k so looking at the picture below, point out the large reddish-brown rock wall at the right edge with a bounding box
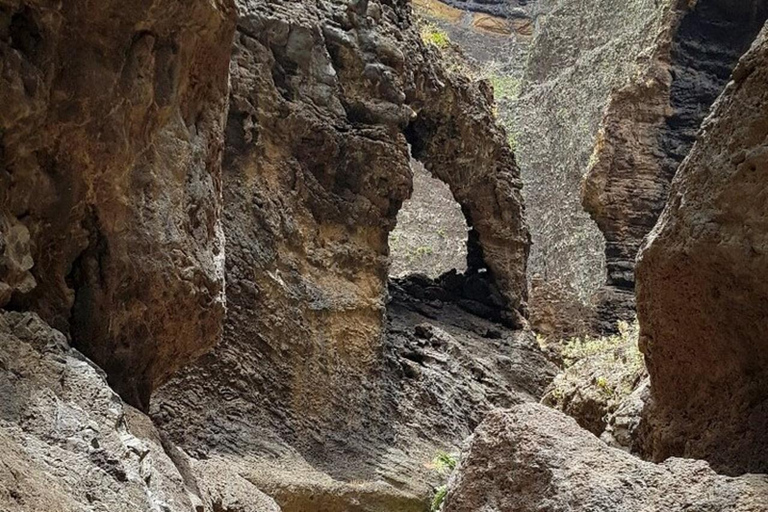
[638,22,768,473]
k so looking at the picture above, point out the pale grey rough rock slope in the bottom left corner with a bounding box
[0,313,279,512]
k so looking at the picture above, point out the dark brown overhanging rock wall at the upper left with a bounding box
[0,0,234,408]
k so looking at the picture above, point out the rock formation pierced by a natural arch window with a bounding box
[153,1,554,511]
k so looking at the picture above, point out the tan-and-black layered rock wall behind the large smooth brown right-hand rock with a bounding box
[583,0,768,328]
